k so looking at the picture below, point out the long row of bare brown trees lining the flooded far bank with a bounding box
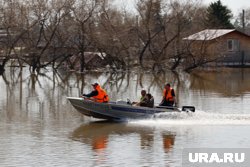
[0,0,247,73]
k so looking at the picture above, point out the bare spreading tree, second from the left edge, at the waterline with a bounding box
[24,0,76,72]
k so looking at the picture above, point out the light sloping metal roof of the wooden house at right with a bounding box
[183,29,237,41]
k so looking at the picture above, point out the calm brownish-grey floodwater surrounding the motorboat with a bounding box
[0,68,250,167]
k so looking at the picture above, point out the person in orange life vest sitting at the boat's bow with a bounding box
[83,83,109,103]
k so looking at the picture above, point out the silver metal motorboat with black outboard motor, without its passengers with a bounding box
[67,97,195,121]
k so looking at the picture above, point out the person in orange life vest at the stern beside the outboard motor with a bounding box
[160,83,177,107]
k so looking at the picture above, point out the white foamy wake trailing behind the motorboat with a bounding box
[130,111,250,125]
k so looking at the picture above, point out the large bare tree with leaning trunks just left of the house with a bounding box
[135,0,203,70]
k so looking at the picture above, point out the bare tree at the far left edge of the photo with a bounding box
[0,0,26,73]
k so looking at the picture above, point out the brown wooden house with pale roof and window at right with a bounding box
[183,29,250,67]
